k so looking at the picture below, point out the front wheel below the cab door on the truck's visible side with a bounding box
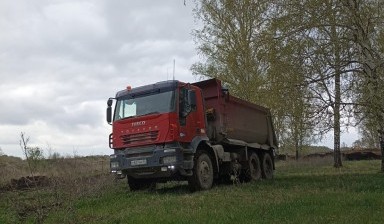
[188,151,213,191]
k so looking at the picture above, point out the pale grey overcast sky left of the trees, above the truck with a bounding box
[0,0,360,156]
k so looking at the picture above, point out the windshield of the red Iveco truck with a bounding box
[114,91,176,121]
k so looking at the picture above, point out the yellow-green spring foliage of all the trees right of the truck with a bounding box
[192,0,384,166]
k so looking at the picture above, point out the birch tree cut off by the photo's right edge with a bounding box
[343,0,384,172]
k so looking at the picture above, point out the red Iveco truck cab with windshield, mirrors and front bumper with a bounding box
[107,81,207,189]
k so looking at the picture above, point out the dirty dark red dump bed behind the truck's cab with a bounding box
[193,79,277,149]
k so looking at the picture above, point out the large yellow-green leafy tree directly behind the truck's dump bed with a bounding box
[192,0,312,156]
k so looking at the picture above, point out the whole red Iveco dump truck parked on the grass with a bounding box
[107,79,278,191]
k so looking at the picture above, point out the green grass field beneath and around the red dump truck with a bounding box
[0,159,384,223]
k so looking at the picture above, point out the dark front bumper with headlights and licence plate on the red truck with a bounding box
[110,145,193,178]
